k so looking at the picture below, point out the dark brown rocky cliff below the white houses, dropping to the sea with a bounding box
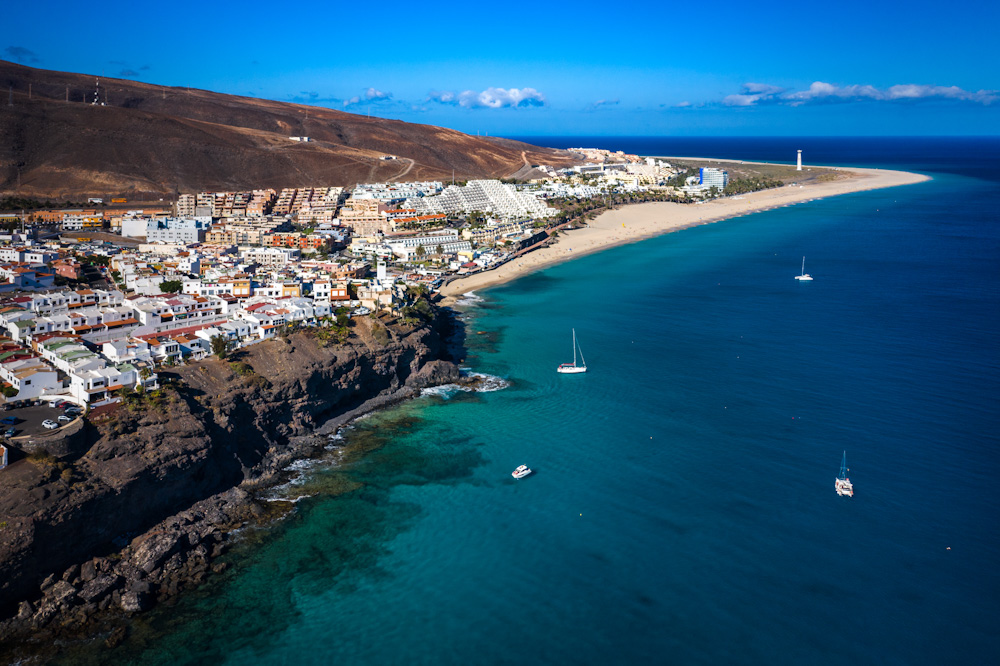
[0,309,462,663]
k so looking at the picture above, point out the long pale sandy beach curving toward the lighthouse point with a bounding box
[441,160,929,304]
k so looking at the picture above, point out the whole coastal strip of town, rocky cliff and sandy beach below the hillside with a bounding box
[0,131,924,650]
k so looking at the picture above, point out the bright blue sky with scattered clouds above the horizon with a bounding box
[0,0,1000,136]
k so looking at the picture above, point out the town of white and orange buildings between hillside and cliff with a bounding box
[0,148,744,465]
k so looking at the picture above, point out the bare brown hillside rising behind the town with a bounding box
[0,61,576,199]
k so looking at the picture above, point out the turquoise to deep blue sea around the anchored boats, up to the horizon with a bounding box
[88,137,1000,666]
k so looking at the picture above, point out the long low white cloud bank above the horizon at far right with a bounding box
[722,81,1000,106]
